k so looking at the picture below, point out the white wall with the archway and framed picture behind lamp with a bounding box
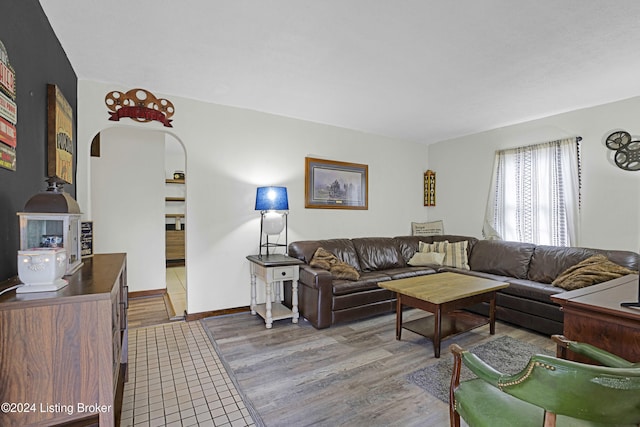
[77,81,427,313]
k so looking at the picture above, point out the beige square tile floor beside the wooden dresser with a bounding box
[121,321,255,427]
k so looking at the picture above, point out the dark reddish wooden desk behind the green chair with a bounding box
[551,274,640,362]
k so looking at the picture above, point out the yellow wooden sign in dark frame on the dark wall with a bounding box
[47,84,73,184]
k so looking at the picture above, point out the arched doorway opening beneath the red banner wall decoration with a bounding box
[90,126,188,319]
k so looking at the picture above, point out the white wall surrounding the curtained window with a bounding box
[428,97,640,252]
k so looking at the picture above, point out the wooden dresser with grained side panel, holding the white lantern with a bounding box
[0,253,128,427]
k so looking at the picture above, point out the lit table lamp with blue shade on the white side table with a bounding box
[255,187,289,257]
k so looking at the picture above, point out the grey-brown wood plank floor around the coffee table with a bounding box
[203,310,555,427]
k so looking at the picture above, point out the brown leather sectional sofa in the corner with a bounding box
[285,235,640,335]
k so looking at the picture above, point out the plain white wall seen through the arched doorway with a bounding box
[90,128,166,291]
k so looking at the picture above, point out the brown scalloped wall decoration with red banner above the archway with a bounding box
[104,89,175,128]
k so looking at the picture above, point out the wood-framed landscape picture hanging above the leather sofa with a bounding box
[304,157,369,210]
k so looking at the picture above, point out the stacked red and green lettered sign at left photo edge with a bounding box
[0,41,18,171]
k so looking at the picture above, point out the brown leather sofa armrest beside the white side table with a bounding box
[298,264,333,329]
